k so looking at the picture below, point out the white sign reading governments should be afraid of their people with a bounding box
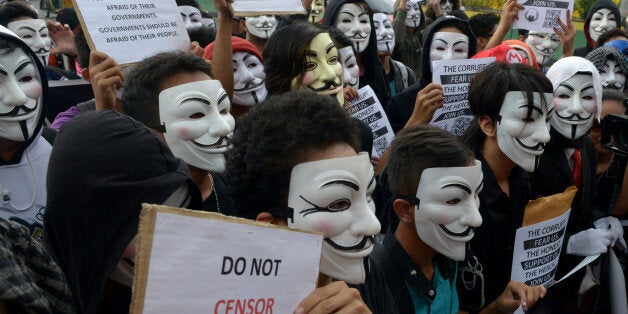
[73,0,190,65]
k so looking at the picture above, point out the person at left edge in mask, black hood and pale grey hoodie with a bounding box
[0,26,54,241]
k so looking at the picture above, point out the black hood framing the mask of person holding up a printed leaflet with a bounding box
[419,15,477,88]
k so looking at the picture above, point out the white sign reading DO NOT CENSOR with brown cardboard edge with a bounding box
[131,204,323,313]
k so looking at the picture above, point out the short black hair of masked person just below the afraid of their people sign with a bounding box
[121,51,212,132]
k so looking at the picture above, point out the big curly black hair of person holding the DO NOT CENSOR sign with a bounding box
[225,91,360,219]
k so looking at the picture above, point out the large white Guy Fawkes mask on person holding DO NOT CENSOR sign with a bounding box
[288,152,380,284]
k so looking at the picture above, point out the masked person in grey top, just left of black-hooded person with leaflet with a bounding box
[373,13,416,96]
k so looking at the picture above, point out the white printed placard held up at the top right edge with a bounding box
[512,0,574,34]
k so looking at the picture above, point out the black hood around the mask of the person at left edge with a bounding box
[0,25,48,146]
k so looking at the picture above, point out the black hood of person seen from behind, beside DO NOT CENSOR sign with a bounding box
[44,110,200,313]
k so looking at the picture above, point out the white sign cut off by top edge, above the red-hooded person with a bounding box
[230,0,307,16]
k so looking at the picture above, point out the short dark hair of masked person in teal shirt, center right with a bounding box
[386,124,475,196]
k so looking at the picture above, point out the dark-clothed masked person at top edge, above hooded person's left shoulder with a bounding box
[392,0,425,77]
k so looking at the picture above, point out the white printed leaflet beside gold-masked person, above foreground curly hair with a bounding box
[346,85,395,158]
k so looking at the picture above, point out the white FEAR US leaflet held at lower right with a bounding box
[510,209,571,288]
